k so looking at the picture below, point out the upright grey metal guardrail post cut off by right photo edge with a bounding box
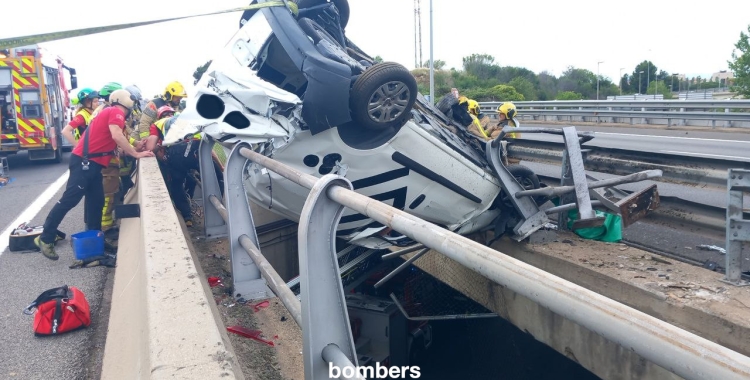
[724,169,750,286]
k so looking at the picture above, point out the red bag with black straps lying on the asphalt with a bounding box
[23,285,91,336]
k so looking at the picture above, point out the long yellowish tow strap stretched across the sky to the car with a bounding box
[0,0,298,49]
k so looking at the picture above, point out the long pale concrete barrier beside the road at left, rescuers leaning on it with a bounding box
[102,158,244,379]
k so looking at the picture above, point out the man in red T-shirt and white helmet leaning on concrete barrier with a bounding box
[34,90,154,260]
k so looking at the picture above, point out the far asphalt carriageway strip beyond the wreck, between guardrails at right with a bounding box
[521,124,750,162]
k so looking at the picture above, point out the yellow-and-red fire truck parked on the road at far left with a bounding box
[0,45,77,162]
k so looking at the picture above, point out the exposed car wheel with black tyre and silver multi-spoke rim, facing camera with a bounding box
[350,62,417,130]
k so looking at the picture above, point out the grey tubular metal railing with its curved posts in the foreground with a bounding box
[200,138,750,380]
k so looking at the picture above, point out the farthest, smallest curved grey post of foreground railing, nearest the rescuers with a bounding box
[198,134,227,239]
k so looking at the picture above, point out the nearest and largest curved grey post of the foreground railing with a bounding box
[298,174,357,380]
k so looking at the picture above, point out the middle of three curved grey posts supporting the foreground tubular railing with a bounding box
[224,143,271,300]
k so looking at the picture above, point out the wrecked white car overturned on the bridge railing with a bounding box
[165,0,660,248]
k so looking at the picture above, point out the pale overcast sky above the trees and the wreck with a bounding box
[0,0,750,96]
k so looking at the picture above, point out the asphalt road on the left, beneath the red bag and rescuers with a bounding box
[0,154,114,380]
